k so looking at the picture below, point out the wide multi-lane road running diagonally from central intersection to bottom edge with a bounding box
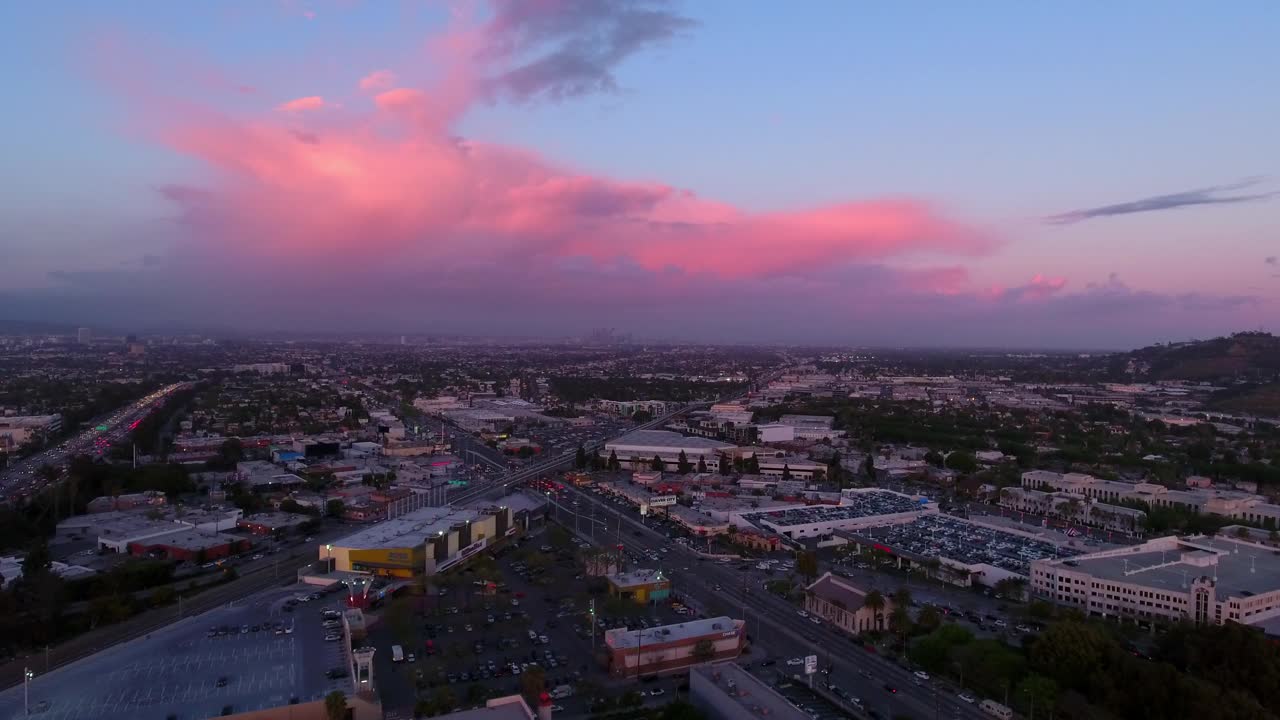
[552,486,986,720]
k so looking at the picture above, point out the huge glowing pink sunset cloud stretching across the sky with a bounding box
[115,3,1000,308]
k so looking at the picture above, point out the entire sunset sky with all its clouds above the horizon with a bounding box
[0,0,1280,348]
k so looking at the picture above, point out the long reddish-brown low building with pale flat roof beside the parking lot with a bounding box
[604,618,745,678]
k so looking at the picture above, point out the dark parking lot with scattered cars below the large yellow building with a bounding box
[369,525,682,714]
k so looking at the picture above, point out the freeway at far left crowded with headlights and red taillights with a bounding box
[0,383,191,501]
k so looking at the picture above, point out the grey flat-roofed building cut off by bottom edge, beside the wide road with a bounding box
[689,662,809,720]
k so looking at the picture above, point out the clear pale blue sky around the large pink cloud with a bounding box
[0,1,1280,345]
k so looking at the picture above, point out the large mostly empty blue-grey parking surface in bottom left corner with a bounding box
[0,587,349,720]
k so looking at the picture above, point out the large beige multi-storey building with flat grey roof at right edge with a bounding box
[1030,536,1280,625]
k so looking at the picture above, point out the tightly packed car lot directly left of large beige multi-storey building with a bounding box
[859,514,1079,577]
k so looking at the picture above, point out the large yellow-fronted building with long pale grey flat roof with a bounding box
[319,505,516,578]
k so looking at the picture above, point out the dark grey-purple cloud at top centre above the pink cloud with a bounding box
[483,0,695,101]
